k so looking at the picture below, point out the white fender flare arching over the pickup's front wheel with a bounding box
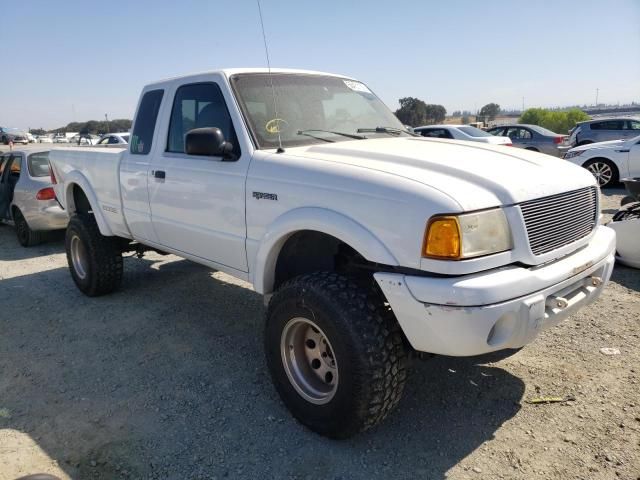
[252,207,398,294]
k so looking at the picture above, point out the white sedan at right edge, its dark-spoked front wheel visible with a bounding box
[564,136,640,187]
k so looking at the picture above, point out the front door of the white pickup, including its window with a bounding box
[148,77,250,272]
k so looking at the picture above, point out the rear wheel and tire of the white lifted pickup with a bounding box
[65,213,122,297]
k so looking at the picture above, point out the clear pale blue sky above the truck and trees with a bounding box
[0,0,640,128]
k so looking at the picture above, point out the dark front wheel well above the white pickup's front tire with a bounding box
[273,230,374,290]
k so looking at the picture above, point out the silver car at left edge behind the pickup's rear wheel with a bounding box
[0,150,68,247]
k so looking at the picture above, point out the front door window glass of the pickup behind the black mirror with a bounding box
[167,83,240,158]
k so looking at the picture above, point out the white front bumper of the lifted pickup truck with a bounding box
[374,226,615,356]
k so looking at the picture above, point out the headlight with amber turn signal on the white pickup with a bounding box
[422,208,513,260]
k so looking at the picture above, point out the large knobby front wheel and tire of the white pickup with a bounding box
[265,272,408,438]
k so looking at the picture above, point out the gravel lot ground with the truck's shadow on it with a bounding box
[0,178,640,480]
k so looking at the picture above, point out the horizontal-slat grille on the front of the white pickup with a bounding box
[520,187,598,255]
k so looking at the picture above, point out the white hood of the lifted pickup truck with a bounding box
[285,137,595,211]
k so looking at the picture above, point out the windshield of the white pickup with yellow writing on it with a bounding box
[231,73,411,148]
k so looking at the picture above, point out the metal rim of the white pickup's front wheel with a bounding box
[280,317,339,405]
